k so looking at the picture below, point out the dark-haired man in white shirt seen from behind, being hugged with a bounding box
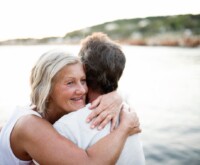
[54,33,145,165]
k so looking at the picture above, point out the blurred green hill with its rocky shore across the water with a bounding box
[0,14,200,47]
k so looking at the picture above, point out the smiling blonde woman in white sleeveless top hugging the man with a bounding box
[0,51,140,165]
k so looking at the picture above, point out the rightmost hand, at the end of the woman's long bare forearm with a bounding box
[119,107,141,136]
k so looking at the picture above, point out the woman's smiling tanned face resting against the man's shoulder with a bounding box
[48,63,88,114]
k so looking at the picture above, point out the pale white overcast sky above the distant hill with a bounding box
[0,0,200,41]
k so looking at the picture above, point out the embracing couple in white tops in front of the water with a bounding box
[0,33,145,165]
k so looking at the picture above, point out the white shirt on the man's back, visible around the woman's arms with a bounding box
[54,105,145,165]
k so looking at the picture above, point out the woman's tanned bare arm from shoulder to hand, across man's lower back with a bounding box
[11,112,140,165]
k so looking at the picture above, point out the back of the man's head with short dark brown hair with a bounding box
[79,33,126,94]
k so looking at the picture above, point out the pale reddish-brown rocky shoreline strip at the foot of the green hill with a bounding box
[0,36,200,47]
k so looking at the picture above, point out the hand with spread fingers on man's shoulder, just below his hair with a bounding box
[87,91,122,131]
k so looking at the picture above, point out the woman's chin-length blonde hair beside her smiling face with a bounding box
[30,50,81,113]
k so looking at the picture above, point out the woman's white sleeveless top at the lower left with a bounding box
[0,106,41,165]
